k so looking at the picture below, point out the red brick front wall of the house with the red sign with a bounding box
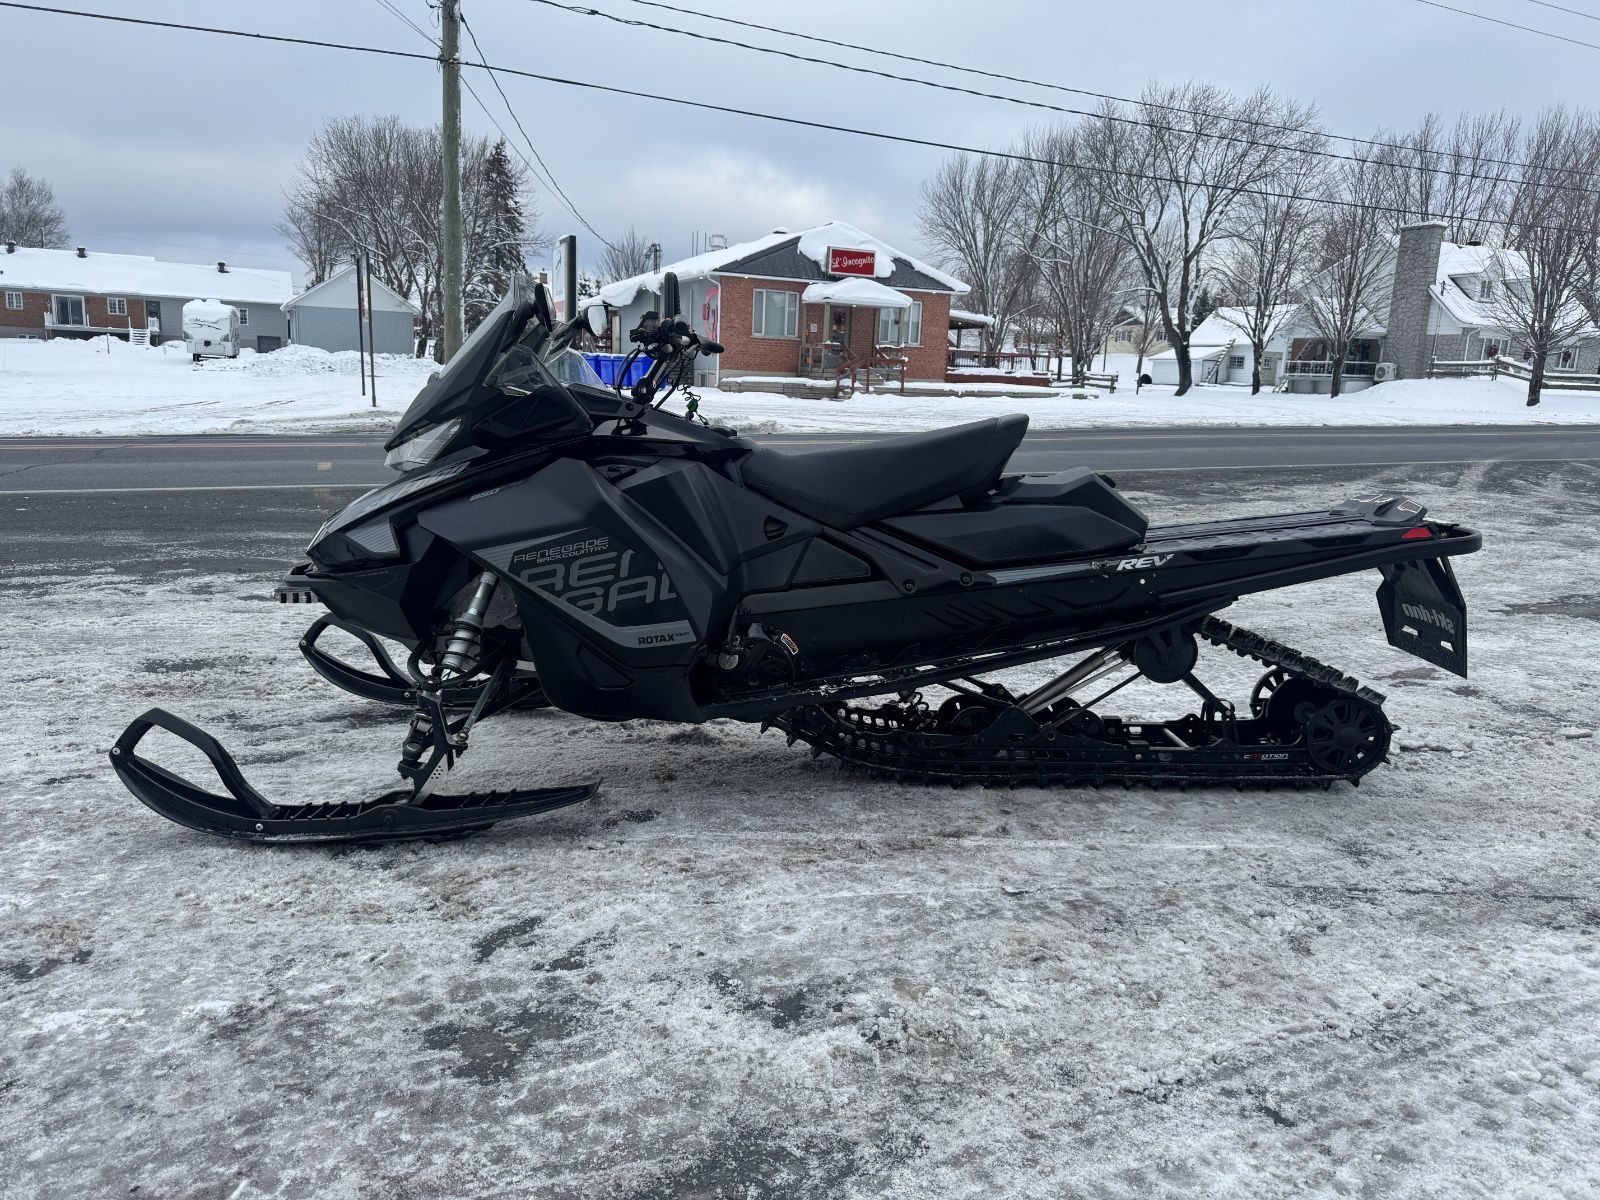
[718,275,950,379]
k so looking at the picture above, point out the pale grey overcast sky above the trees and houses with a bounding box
[0,0,1600,281]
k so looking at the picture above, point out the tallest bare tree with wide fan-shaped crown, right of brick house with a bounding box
[1083,83,1322,395]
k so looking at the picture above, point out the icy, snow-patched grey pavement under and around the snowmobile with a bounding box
[0,464,1600,1200]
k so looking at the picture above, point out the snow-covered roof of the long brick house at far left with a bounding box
[0,246,294,304]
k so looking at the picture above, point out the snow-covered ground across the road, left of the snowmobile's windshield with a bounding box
[0,338,435,437]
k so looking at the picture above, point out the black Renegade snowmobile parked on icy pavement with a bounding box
[110,275,1482,842]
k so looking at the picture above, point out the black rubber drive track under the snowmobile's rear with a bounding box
[773,616,1392,787]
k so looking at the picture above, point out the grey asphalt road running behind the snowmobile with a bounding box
[0,426,1600,496]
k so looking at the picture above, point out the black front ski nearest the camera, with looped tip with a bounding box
[110,709,598,845]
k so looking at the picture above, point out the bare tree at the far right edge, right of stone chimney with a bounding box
[1478,109,1600,406]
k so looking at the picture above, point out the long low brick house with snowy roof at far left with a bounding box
[0,242,294,350]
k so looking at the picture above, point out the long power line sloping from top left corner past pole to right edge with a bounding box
[0,0,1584,234]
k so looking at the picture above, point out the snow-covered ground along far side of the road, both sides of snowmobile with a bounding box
[0,339,1600,437]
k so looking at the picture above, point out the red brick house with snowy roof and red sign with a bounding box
[598,221,968,384]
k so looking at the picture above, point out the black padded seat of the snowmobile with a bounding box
[742,414,1027,530]
